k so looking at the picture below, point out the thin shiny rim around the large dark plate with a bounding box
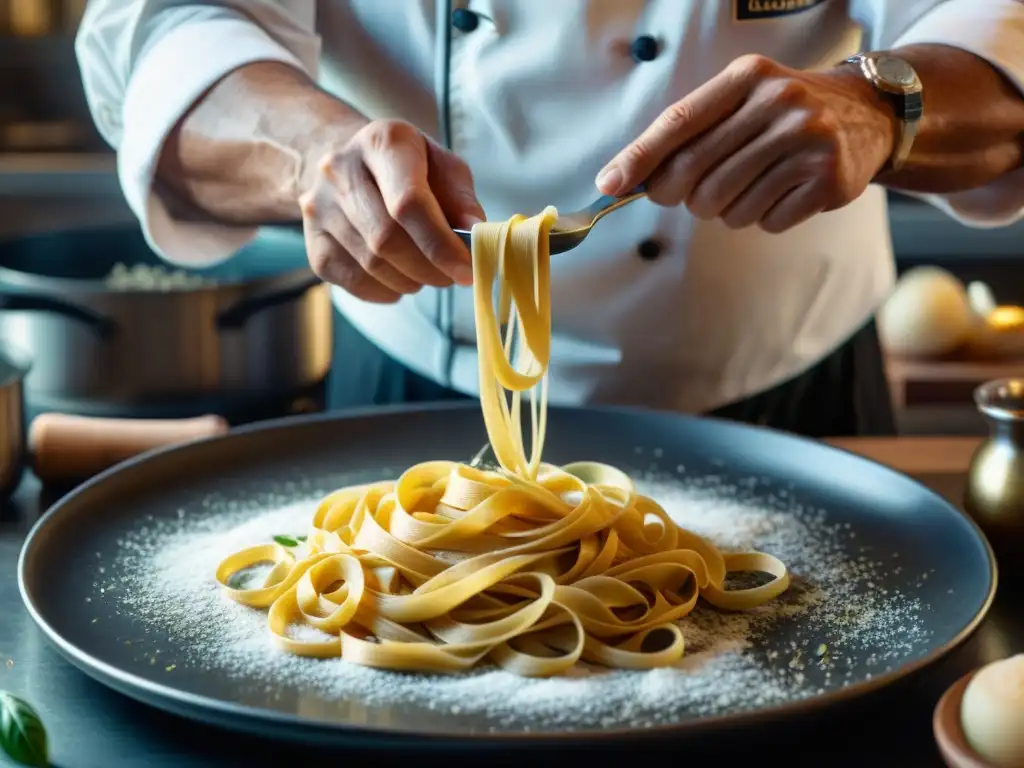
[17,399,998,746]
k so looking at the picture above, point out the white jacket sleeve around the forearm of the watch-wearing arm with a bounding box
[854,0,1024,228]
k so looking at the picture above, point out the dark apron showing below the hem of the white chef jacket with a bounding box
[328,315,896,437]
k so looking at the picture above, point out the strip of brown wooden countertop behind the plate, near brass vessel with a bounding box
[825,437,983,474]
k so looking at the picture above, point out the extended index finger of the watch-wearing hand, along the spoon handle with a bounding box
[596,55,778,195]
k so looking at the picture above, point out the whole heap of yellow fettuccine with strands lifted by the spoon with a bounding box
[216,208,790,677]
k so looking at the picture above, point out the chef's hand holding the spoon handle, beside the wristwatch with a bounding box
[597,55,895,232]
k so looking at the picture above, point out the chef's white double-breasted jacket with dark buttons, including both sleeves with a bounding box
[77,0,1024,412]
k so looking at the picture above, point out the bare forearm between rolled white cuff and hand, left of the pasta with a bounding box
[157,61,367,224]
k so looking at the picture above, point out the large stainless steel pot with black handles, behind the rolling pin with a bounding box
[0,227,332,404]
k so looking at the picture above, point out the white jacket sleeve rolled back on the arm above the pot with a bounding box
[75,0,319,266]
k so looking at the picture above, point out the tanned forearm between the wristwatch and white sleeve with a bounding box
[878,45,1024,194]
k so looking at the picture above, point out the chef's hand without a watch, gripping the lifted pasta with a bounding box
[299,120,483,303]
